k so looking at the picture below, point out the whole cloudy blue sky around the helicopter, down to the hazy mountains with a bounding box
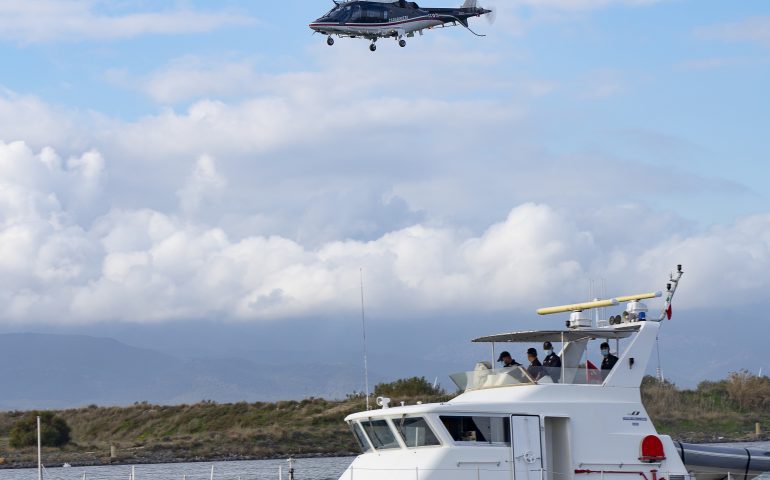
[0,0,770,326]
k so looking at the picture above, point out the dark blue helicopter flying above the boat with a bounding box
[309,0,494,52]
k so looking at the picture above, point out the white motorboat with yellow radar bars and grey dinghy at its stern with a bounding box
[340,266,770,480]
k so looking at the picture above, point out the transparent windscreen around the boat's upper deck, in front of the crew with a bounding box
[449,365,609,392]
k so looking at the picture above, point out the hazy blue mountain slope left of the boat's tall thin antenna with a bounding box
[0,334,372,410]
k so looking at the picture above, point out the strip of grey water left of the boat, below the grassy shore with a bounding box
[0,457,353,480]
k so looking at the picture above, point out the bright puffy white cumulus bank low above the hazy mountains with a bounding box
[0,142,770,322]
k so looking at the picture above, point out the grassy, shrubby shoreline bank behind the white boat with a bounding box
[0,371,770,469]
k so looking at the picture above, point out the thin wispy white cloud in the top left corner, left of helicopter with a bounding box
[0,0,254,43]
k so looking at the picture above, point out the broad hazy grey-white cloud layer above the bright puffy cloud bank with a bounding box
[0,54,745,247]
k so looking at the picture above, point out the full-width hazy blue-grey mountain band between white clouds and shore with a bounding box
[0,307,770,410]
